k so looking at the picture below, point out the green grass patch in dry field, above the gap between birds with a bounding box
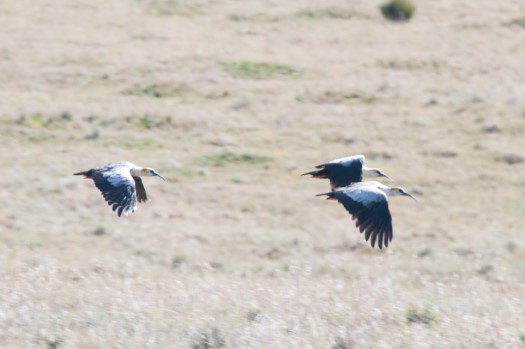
[221,61,298,79]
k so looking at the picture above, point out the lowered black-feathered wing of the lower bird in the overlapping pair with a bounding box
[334,190,393,249]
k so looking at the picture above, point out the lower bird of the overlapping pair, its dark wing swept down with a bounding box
[317,181,416,249]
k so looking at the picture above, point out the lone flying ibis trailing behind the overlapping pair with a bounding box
[74,161,166,217]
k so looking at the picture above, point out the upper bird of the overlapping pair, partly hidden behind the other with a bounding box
[302,155,392,188]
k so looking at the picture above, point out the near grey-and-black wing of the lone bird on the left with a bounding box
[93,167,137,217]
